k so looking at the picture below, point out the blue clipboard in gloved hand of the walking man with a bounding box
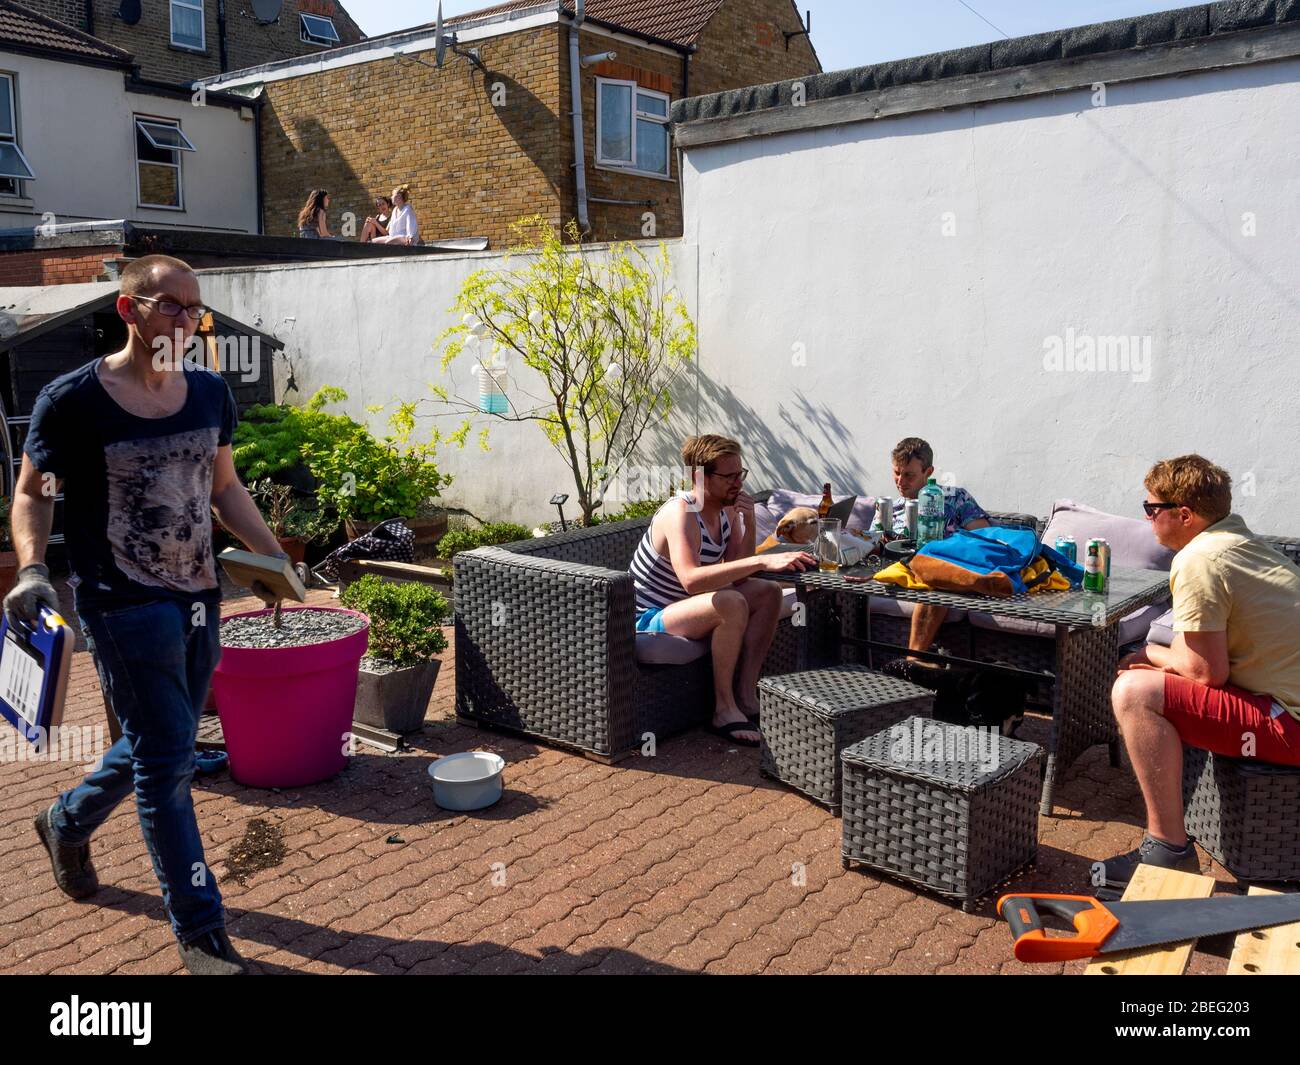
[0,606,77,745]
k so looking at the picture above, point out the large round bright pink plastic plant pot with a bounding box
[212,607,371,788]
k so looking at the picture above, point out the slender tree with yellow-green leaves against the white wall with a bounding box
[430,216,697,524]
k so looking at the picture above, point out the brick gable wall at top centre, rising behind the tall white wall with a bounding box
[690,0,822,96]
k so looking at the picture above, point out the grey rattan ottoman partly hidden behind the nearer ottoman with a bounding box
[758,664,935,813]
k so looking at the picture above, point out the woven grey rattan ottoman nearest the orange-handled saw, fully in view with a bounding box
[841,718,1043,909]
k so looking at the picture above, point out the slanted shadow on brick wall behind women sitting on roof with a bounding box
[261,100,366,239]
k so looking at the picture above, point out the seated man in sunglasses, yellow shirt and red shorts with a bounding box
[1102,455,1300,888]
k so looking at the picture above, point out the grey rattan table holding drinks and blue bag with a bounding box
[759,566,1169,815]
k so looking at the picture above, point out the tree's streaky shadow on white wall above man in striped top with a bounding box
[641,365,873,494]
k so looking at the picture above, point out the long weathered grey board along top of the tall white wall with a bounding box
[672,22,1300,148]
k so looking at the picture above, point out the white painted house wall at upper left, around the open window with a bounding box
[0,52,257,233]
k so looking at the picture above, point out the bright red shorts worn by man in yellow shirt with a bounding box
[1165,674,1300,766]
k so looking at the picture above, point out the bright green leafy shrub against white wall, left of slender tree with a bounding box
[303,403,451,545]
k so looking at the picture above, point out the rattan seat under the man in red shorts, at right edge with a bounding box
[1183,746,1300,880]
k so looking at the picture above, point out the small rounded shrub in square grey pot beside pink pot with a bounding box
[339,573,451,732]
